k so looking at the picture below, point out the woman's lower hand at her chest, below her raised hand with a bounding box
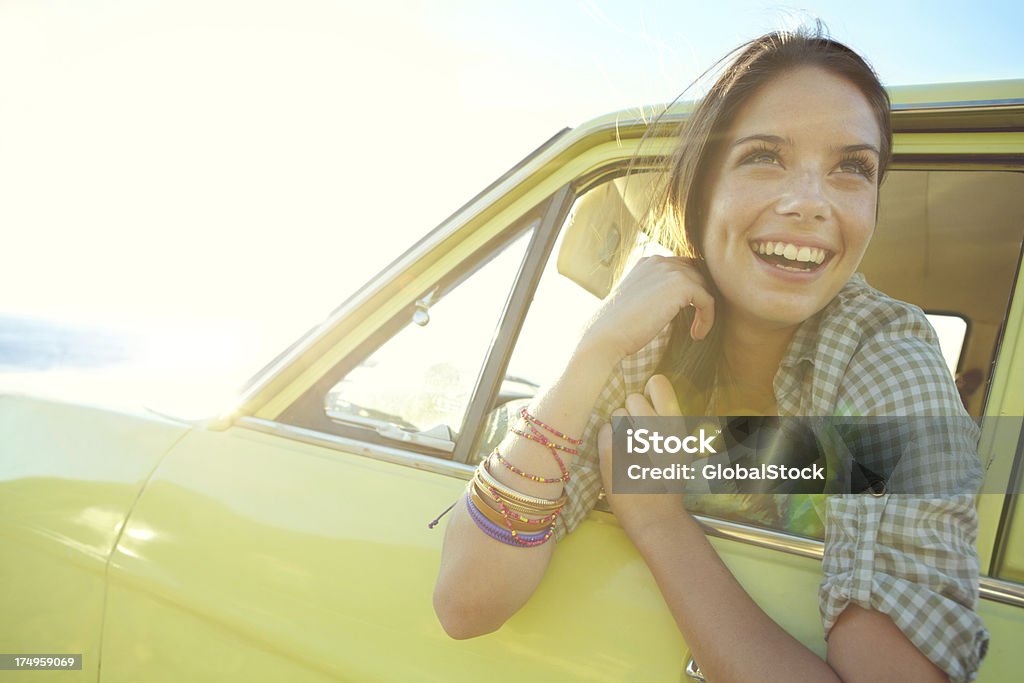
[597,375,687,543]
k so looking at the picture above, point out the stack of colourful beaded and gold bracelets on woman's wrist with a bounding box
[466,408,581,548]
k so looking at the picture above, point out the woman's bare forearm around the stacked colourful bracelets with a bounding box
[433,345,617,638]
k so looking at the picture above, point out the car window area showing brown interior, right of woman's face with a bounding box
[861,168,1024,417]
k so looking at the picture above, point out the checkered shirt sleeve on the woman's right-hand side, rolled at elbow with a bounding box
[819,300,988,683]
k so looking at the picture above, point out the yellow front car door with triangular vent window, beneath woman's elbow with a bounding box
[96,183,696,681]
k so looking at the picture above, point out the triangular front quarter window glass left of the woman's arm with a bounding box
[324,226,532,451]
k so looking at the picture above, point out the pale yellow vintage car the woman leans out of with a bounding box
[0,80,1024,683]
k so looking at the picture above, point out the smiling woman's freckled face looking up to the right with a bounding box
[702,67,882,328]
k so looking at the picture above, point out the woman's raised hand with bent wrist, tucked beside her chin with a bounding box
[581,256,715,361]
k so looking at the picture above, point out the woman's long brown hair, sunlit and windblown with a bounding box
[629,22,892,412]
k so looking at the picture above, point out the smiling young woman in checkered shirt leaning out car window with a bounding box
[434,26,987,683]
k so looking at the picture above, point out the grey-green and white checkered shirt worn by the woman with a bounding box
[556,274,988,682]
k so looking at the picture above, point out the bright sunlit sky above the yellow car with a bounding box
[0,0,1024,413]
